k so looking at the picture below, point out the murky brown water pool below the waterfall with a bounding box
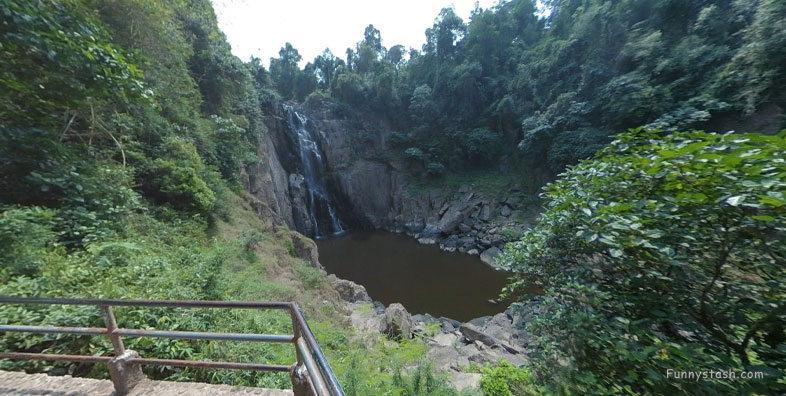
[317,231,511,321]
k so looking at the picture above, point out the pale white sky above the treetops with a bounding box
[212,0,498,66]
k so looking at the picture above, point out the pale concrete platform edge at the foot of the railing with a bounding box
[0,371,292,396]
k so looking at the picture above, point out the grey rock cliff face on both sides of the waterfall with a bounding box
[251,100,531,264]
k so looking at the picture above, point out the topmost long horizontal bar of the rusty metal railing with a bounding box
[0,296,291,310]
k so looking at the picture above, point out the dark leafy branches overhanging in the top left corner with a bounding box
[0,0,151,126]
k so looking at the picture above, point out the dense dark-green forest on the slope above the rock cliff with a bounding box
[268,0,786,175]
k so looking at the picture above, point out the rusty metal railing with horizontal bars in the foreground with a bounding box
[0,296,344,396]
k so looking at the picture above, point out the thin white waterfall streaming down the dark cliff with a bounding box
[284,105,344,237]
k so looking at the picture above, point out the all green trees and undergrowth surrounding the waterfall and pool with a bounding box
[0,0,786,396]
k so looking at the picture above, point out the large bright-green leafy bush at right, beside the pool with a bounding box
[503,130,786,394]
